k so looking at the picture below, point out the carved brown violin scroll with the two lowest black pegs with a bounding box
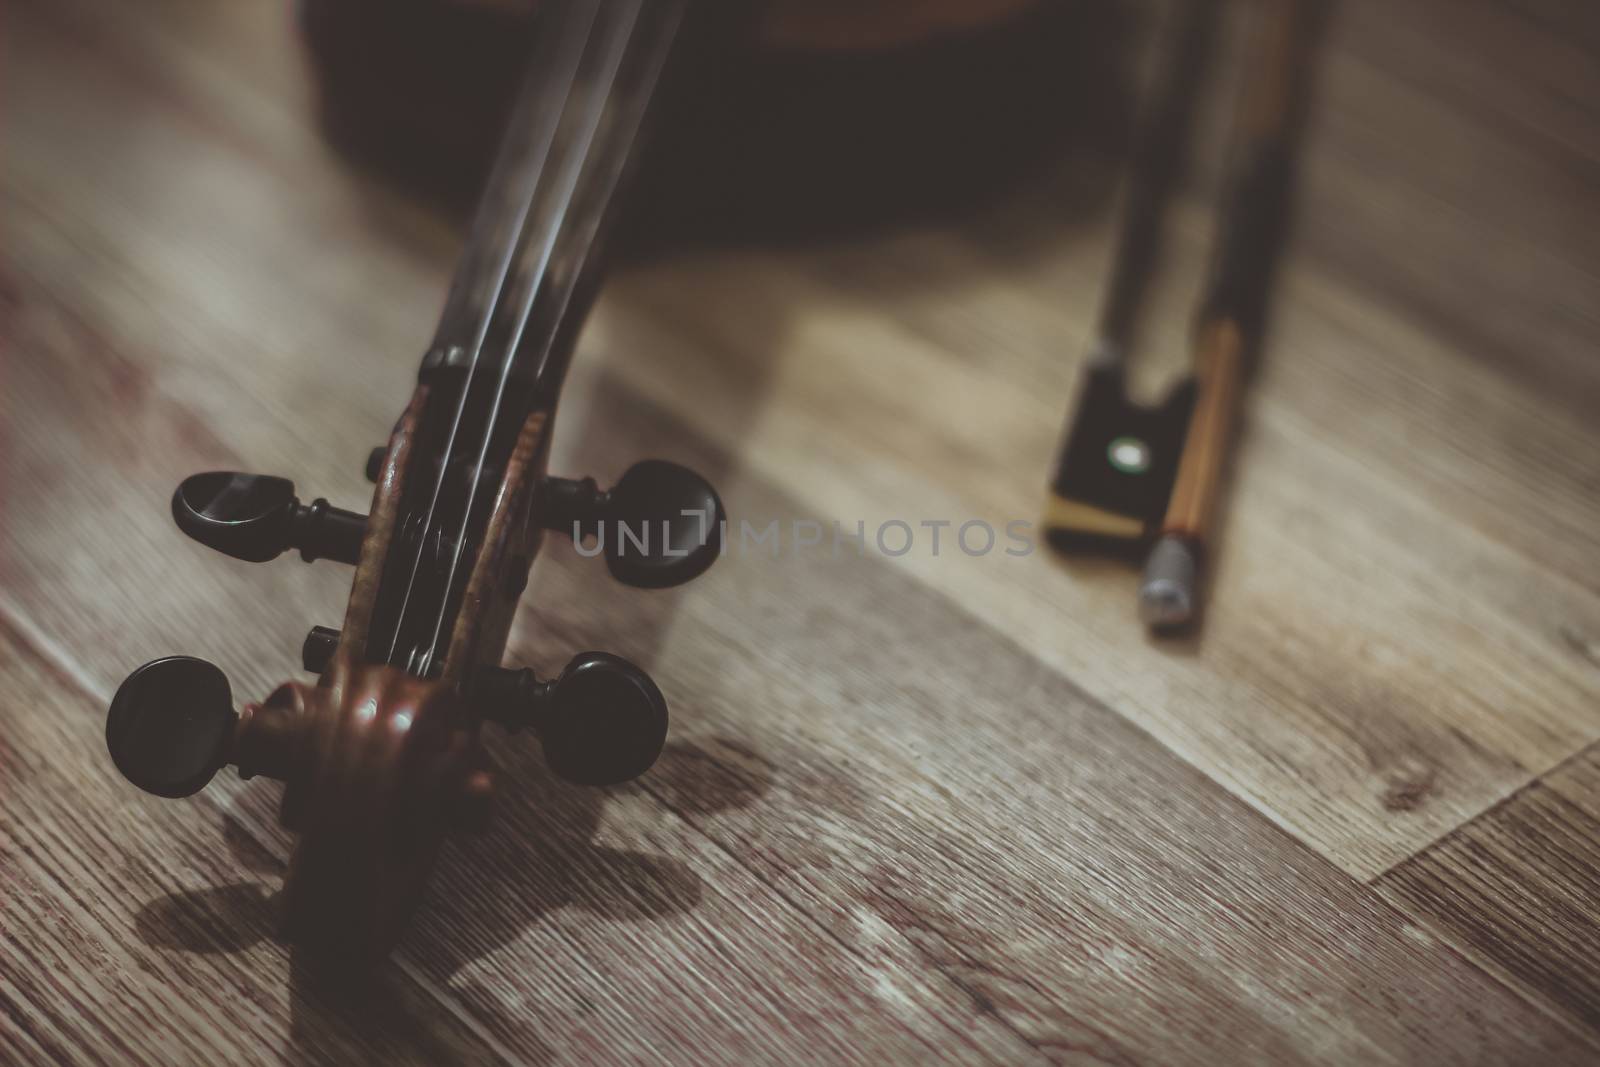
[106,639,667,963]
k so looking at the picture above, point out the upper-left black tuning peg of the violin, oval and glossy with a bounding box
[173,470,366,563]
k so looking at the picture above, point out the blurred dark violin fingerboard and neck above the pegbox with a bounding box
[422,0,685,398]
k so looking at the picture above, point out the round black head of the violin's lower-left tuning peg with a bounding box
[106,656,238,798]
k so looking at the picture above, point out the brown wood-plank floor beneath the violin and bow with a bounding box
[0,0,1600,1065]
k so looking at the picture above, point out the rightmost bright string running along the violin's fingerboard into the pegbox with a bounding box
[424,0,656,670]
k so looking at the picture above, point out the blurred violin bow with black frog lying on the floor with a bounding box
[1045,0,1328,630]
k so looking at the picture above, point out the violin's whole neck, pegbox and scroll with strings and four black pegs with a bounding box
[106,0,1043,961]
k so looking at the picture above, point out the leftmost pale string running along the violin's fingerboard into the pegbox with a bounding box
[384,0,600,662]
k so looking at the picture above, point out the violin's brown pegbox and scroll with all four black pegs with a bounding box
[106,419,725,961]
